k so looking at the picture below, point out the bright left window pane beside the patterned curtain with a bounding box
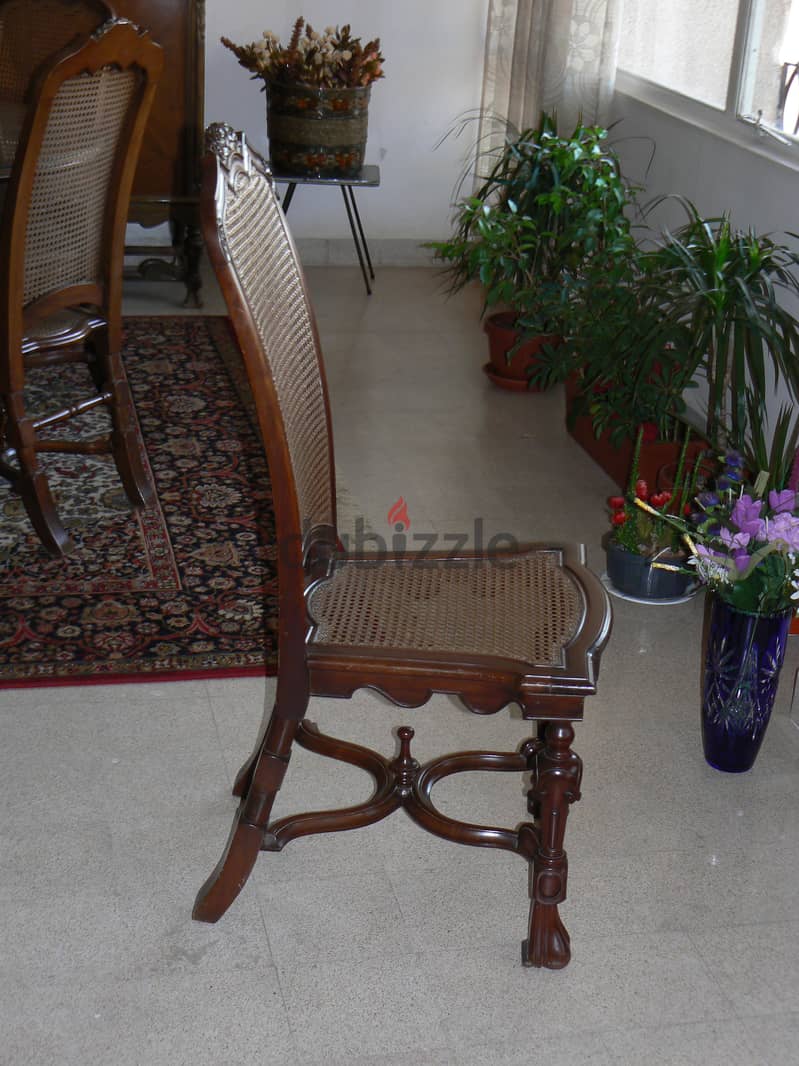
[619,0,737,109]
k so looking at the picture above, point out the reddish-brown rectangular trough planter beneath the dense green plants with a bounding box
[566,378,708,490]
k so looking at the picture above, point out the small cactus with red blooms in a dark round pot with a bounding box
[605,430,701,601]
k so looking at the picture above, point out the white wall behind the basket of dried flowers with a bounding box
[206,0,488,262]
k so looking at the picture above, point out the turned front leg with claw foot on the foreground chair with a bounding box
[522,722,583,970]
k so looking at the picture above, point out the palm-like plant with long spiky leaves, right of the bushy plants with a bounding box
[642,200,799,451]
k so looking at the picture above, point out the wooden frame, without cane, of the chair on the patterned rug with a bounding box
[0,19,163,555]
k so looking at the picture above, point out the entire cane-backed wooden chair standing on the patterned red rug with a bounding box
[0,19,163,555]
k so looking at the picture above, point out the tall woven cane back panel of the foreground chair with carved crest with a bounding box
[209,126,336,539]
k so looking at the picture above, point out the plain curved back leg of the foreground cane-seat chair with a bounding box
[192,699,307,922]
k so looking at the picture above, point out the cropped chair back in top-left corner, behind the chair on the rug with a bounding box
[0,0,114,103]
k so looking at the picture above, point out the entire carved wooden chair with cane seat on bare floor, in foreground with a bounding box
[194,124,610,968]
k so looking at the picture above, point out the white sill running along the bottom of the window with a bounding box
[616,70,799,172]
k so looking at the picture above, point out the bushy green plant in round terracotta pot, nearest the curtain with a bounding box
[427,114,633,388]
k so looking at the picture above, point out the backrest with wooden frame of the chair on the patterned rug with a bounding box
[1,20,163,328]
